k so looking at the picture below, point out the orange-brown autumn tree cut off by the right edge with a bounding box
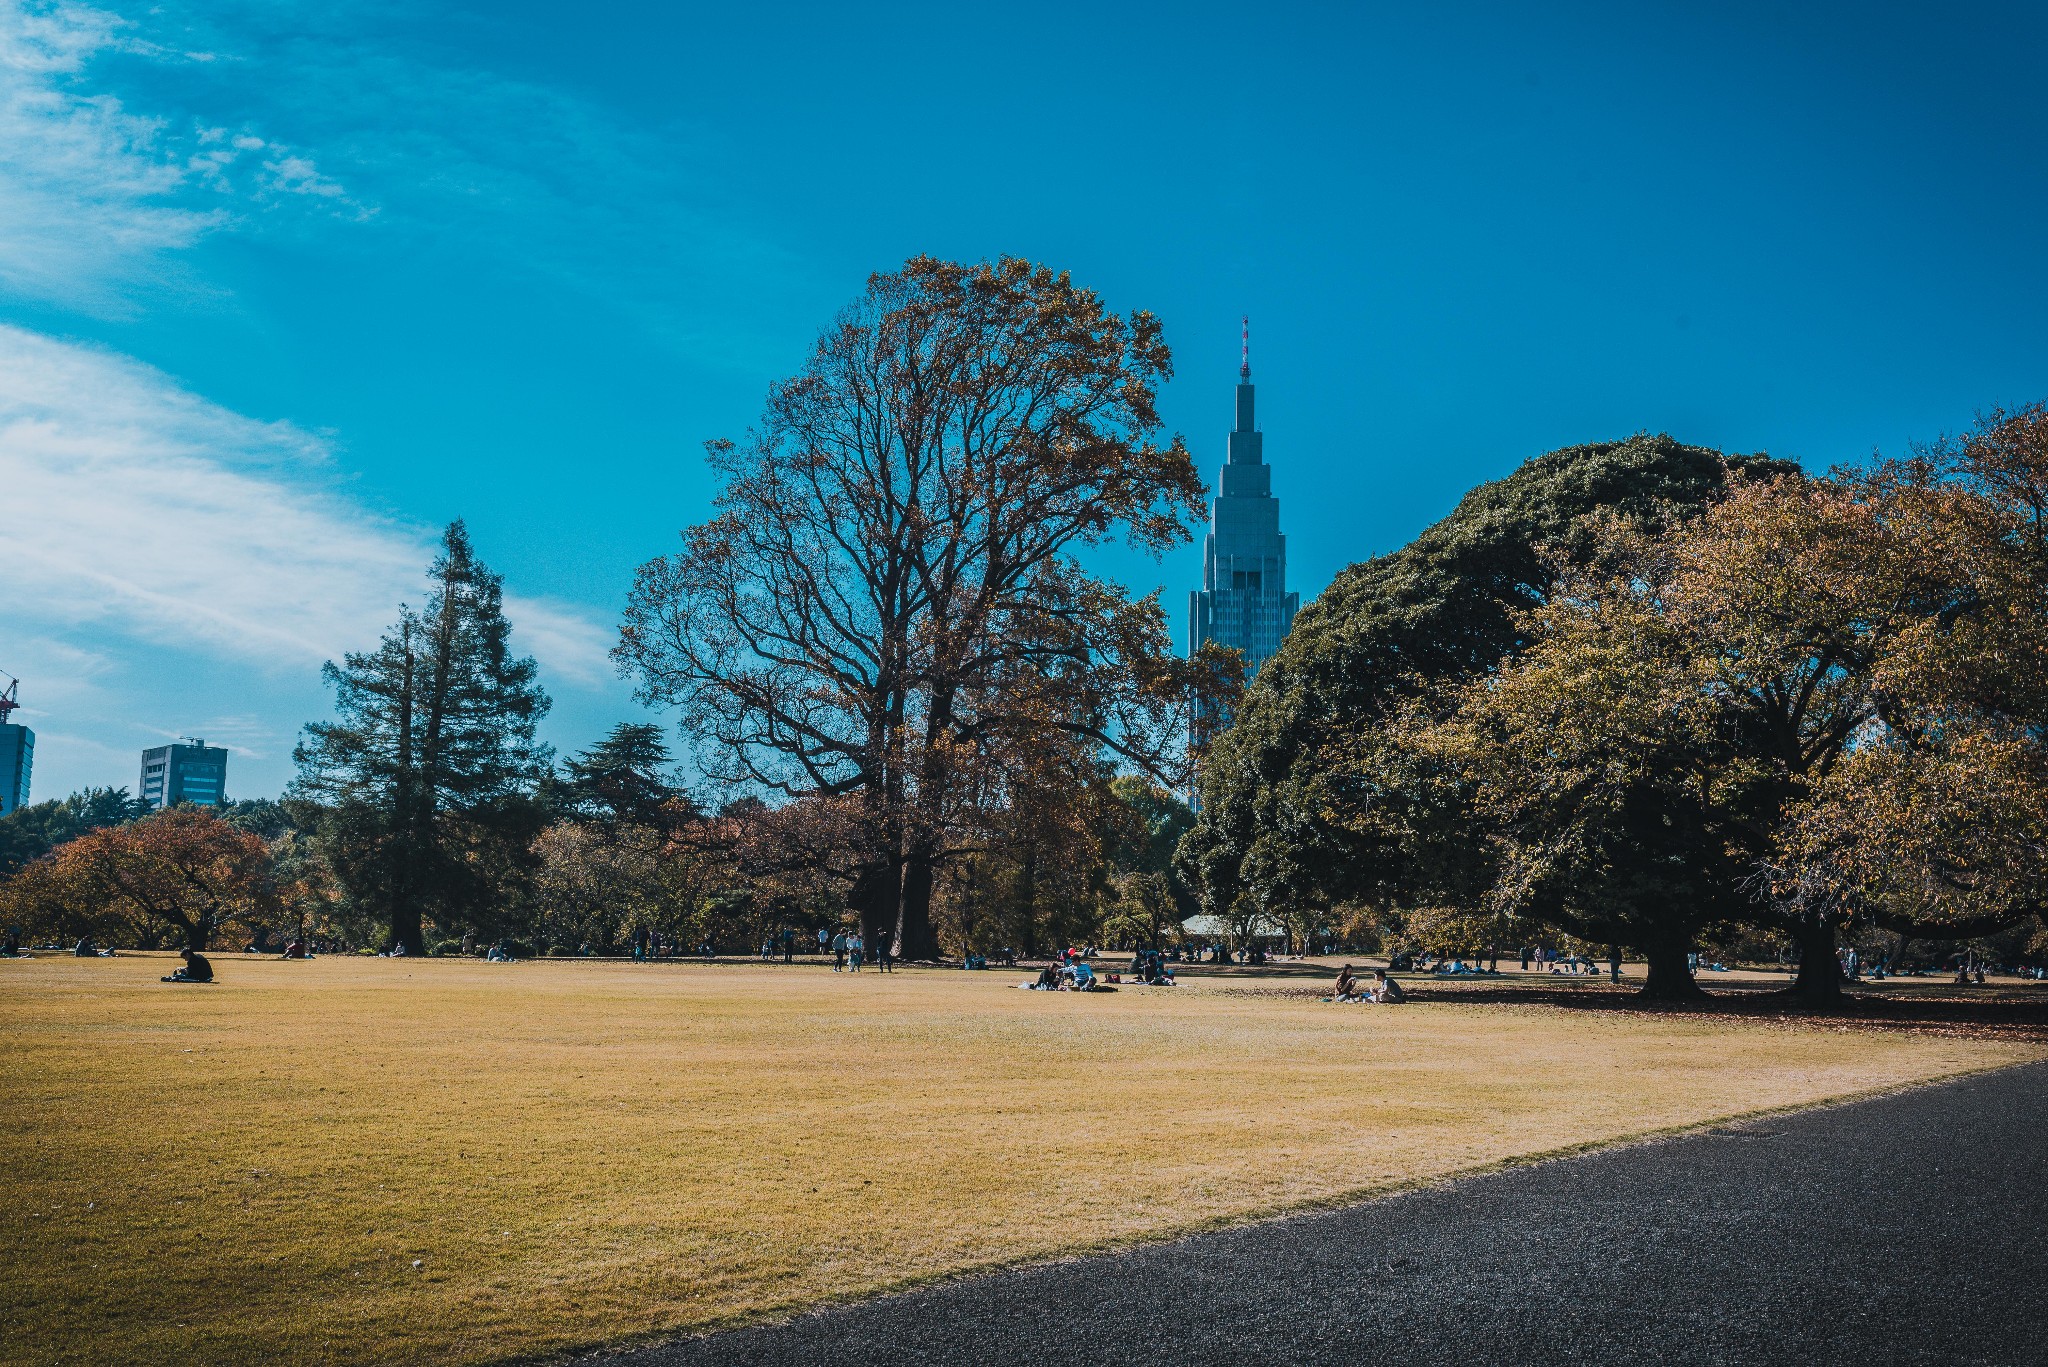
[1769,404,2048,971]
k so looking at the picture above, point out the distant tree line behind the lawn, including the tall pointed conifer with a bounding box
[0,493,1192,955]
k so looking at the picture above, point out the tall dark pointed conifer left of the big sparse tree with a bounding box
[293,523,553,953]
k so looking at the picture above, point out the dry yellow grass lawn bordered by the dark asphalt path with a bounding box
[0,955,2030,1363]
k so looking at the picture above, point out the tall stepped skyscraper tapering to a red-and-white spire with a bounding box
[1188,320,1300,696]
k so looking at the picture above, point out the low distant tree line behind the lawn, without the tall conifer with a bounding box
[0,741,1194,957]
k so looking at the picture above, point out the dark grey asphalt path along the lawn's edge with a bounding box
[606,1064,2048,1367]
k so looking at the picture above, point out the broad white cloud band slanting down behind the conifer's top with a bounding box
[0,326,610,682]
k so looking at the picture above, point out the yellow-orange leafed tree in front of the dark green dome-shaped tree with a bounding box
[1409,485,1917,996]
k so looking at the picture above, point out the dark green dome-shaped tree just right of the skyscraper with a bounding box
[1178,437,1788,967]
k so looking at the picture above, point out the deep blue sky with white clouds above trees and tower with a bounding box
[0,0,2048,797]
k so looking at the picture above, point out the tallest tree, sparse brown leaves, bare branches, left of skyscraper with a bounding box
[614,256,1214,957]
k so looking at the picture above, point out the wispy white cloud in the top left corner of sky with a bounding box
[0,0,369,314]
